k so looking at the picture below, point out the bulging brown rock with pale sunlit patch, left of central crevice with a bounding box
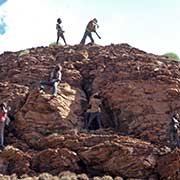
[15,84,82,148]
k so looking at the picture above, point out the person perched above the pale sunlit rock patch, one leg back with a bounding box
[39,65,62,97]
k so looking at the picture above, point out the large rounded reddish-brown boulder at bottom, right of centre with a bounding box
[78,135,157,178]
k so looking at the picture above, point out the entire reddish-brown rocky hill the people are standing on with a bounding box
[0,44,180,180]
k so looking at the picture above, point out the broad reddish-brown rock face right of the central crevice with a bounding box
[89,46,180,144]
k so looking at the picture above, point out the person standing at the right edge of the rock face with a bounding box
[170,113,180,148]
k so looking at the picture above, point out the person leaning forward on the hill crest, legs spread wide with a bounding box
[80,18,101,45]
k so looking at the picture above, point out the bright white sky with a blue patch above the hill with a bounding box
[0,0,180,56]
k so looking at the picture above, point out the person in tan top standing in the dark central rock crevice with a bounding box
[86,93,102,129]
